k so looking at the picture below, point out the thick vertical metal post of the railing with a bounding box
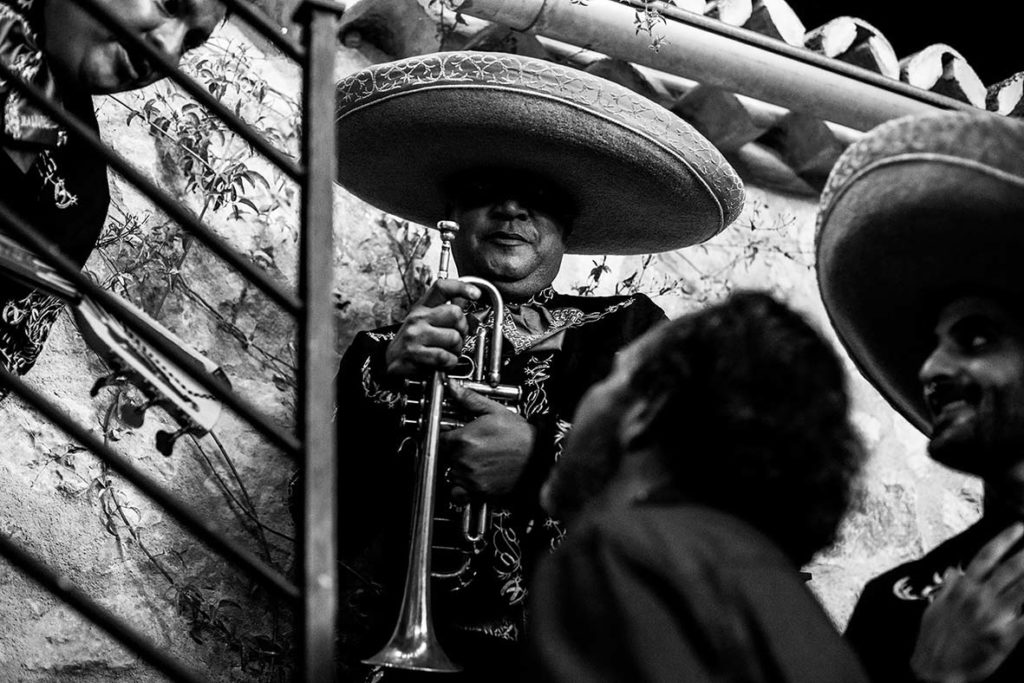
[298,0,343,683]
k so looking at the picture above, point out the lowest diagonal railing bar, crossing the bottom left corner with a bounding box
[0,533,207,683]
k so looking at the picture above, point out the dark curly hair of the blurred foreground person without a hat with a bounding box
[630,291,864,565]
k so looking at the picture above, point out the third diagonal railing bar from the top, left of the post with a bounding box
[0,60,302,315]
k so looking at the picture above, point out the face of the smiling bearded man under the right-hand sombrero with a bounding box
[920,297,1024,477]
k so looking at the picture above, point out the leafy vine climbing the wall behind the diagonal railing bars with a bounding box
[78,31,299,681]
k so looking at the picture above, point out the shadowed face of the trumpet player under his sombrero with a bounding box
[452,174,567,299]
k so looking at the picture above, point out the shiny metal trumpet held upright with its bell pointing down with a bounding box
[365,220,522,672]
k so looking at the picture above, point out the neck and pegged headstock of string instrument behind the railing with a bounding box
[0,234,230,456]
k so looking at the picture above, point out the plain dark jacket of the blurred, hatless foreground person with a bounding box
[522,500,867,683]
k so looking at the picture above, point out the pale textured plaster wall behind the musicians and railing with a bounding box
[0,6,980,681]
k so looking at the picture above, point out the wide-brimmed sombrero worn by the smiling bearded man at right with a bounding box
[816,112,1024,433]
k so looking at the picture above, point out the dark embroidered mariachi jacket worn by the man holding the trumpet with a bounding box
[338,289,666,679]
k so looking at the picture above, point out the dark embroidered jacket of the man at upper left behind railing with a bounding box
[0,0,110,385]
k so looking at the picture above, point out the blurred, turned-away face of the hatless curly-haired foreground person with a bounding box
[541,337,646,519]
